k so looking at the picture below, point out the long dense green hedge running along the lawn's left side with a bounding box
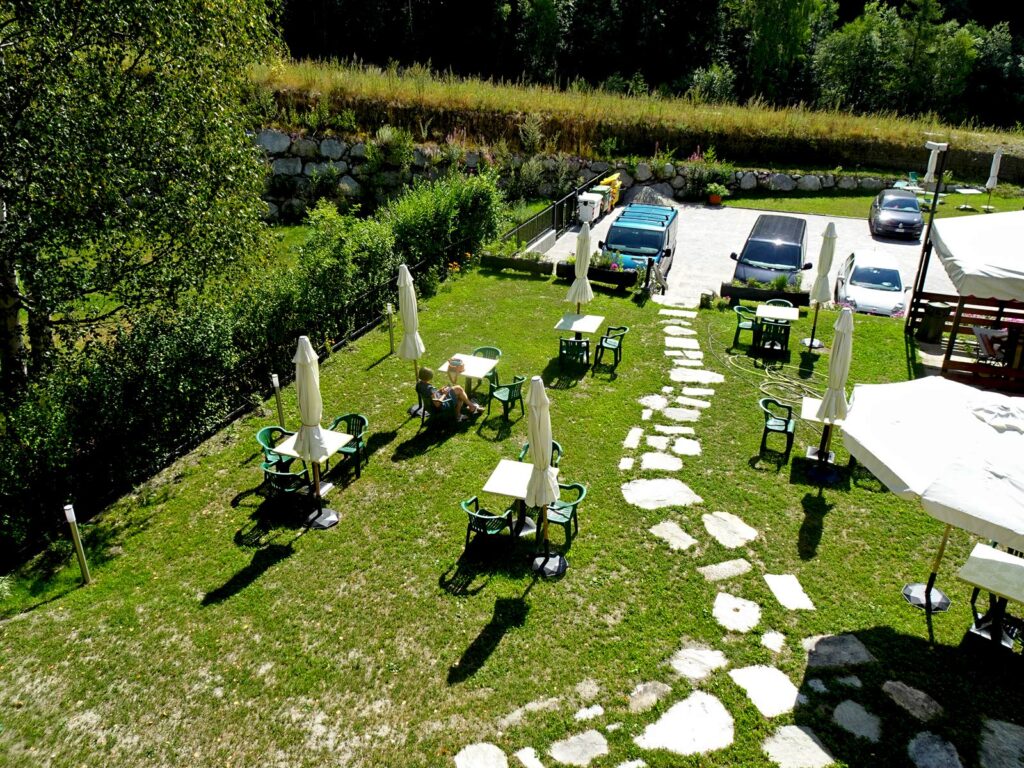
[0,174,502,564]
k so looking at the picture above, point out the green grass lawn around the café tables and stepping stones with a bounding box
[0,273,1020,768]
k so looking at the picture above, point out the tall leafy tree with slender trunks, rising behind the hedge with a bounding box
[0,0,272,393]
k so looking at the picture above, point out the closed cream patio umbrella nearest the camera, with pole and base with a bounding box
[526,376,568,575]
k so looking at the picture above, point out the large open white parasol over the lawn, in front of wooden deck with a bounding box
[843,376,1024,610]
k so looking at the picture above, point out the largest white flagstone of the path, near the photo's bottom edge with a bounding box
[633,691,734,755]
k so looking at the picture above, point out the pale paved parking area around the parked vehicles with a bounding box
[547,203,956,313]
